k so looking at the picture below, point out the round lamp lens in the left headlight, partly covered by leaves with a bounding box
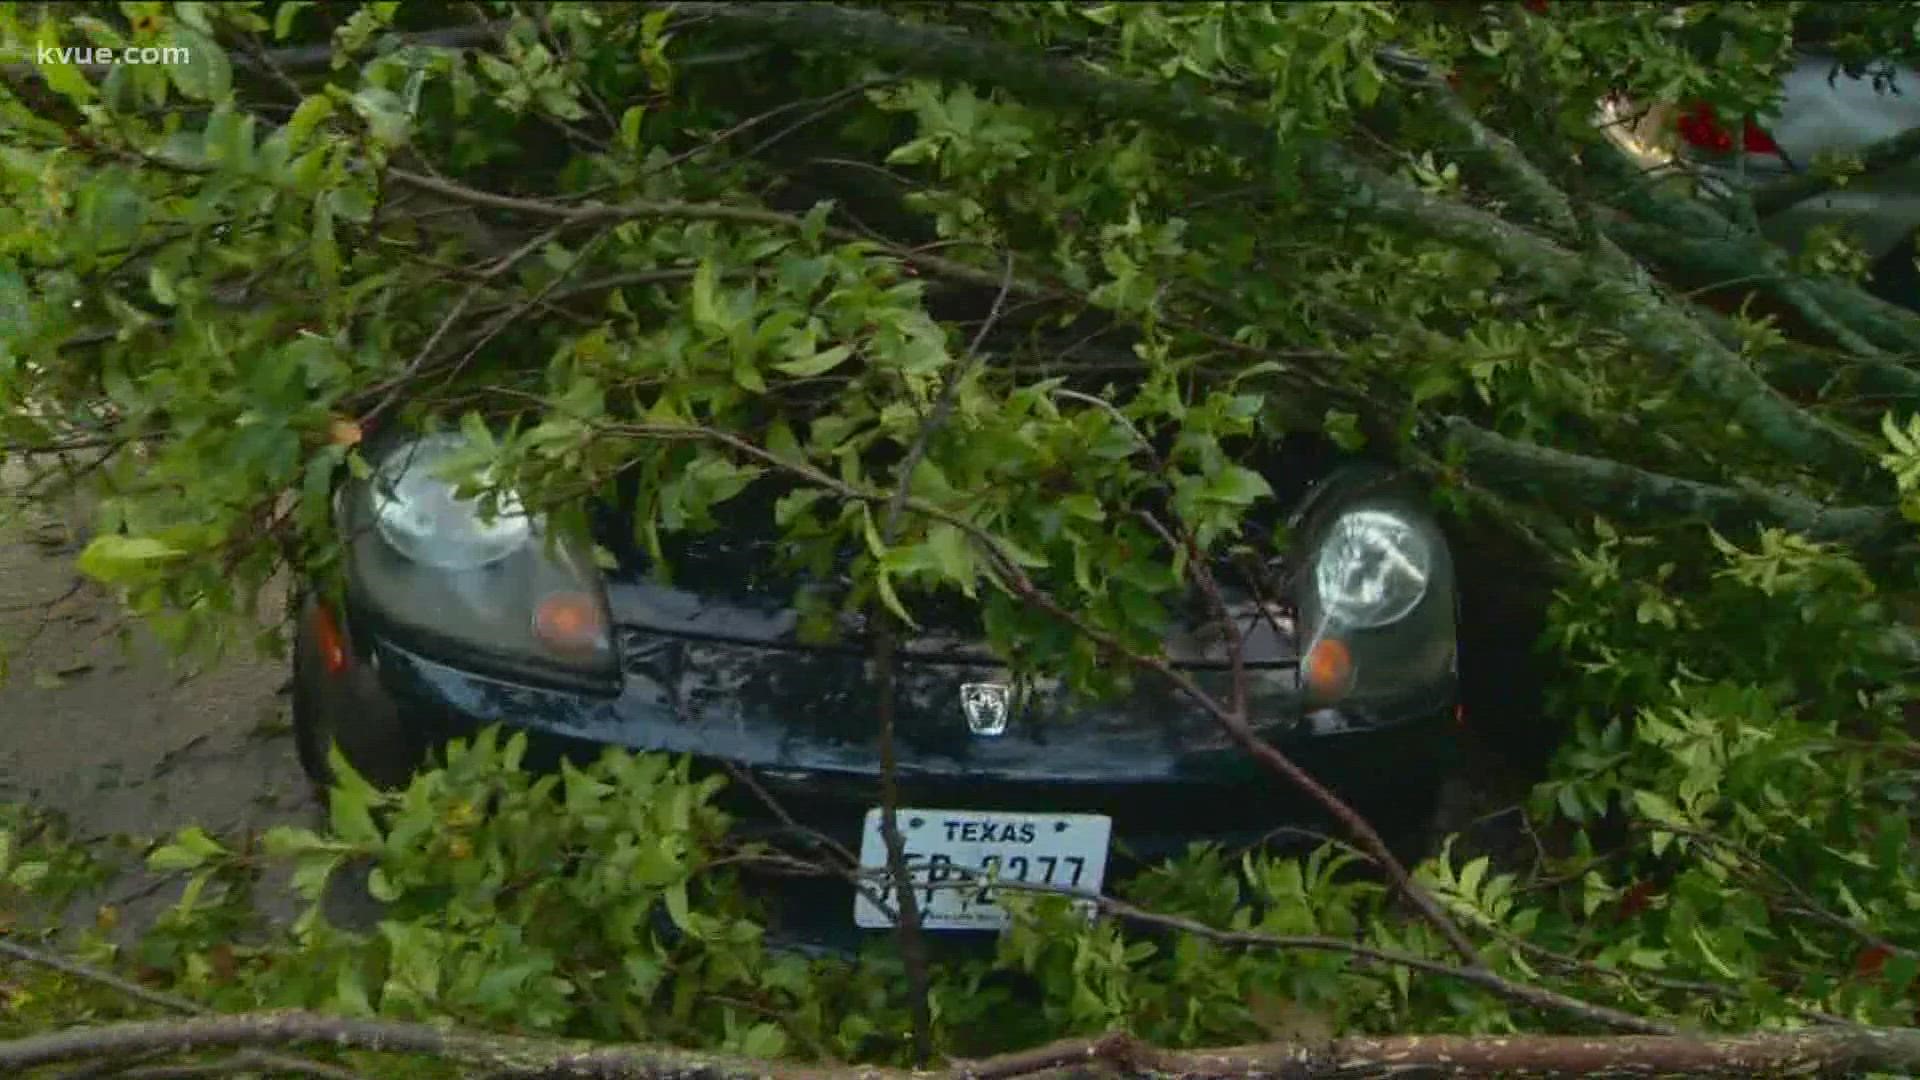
[372,434,532,571]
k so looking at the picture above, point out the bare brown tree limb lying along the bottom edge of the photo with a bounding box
[0,1013,1920,1080]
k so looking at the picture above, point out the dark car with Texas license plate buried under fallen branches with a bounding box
[294,426,1457,942]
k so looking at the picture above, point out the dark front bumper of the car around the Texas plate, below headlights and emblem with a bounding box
[307,599,1457,947]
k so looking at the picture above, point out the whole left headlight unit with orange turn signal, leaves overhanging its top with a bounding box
[340,434,618,688]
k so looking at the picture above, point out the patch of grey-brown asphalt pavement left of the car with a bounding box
[0,469,319,930]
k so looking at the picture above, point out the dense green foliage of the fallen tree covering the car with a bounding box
[11,2,1920,1061]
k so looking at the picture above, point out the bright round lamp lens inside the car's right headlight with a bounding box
[1313,509,1432,628]
